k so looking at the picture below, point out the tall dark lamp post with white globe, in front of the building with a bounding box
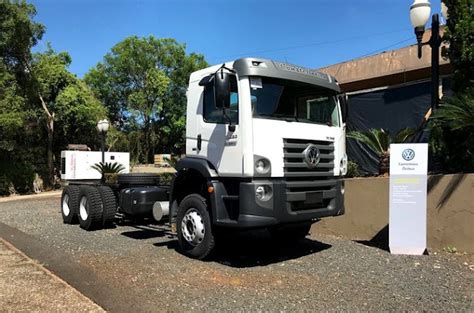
[410,0,448,111]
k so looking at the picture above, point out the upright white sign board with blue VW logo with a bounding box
[389,143,428,255]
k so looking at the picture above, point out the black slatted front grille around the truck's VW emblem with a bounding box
[283,139,337,211]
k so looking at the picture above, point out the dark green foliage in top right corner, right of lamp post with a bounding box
[443,0,474,92]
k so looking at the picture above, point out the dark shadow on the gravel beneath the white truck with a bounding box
[122,225,331,268]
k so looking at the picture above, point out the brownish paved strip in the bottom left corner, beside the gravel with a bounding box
[0,240,104,312]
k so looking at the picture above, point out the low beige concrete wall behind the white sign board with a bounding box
[312,174,474,253]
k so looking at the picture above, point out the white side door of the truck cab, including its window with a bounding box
[196,75,242,176]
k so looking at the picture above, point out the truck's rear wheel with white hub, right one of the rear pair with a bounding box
[77,186,103,230]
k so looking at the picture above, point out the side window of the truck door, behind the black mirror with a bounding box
[203,76,239,125]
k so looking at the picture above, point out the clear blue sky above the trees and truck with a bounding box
[29,0,440,77]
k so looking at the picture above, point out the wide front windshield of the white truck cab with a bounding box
[250,77,339,126]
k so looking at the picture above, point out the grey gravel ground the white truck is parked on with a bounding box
[0,198,474,312]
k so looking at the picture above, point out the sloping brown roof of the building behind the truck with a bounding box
[318,29,452,92]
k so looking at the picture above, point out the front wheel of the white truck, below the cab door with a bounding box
[176,194,215,260]
